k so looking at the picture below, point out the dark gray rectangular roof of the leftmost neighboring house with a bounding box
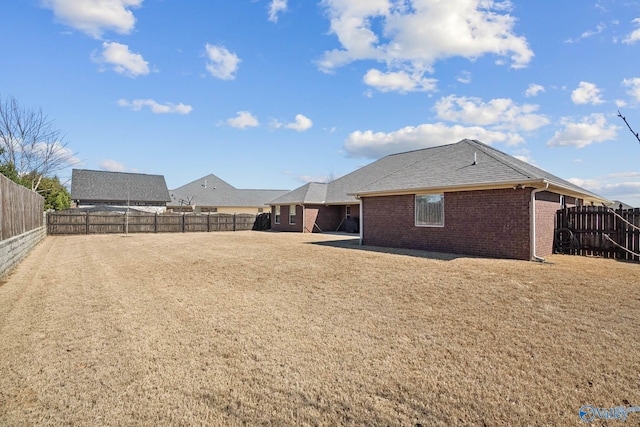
[71,169,171,203]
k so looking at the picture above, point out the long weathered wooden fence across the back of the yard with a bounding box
[47,211,270,235]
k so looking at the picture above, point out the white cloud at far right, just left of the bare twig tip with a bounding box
[547,114,618,148]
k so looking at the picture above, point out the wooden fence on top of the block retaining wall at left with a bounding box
[0,174,44,241]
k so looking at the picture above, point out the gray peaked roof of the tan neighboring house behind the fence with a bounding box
[169,174,288,207]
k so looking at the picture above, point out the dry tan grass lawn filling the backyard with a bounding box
[0,232,640,426]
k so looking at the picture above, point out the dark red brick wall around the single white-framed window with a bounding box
[363,188,532,260]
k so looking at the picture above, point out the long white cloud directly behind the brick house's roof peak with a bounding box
[344,123,520,159]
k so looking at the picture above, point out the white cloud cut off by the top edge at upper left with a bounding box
[42,0,143,38]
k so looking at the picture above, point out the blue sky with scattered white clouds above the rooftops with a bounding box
[0,0,640,206]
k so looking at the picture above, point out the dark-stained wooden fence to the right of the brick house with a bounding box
[554,206,640,261]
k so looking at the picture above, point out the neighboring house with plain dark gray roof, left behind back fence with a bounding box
[71,169,171,212]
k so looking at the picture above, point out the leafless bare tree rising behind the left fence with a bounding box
[0,97,75,191]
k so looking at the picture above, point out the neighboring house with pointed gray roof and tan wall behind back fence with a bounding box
[168,174,288,214]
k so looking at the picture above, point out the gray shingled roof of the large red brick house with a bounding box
[270,139,604,205]
